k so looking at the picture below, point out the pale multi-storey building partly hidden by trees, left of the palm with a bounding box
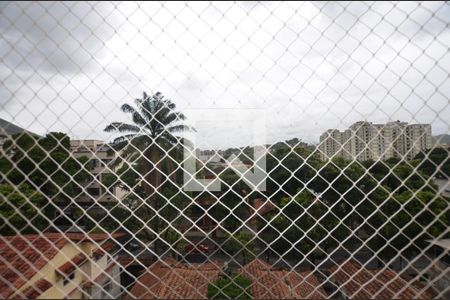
[70,140,126,205]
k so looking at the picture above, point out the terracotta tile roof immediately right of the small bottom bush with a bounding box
[240,259,326,299]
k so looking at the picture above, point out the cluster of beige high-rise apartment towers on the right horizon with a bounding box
[319,121,432,160]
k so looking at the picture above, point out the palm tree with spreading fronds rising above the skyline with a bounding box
[105,92,195,209]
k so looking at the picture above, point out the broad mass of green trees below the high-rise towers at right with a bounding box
[250,146,450,258]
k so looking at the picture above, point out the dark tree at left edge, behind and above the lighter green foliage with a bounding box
[0,132,88,218]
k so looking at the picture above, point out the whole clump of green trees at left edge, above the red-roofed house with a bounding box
[0,132,89,234]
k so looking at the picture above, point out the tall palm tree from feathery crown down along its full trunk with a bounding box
[105,92,194,248]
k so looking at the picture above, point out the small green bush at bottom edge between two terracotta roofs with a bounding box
[208,275,252,299]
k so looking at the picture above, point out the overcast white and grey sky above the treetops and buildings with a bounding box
[0,2,450,148]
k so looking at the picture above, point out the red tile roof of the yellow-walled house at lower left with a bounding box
[0,233,121,298]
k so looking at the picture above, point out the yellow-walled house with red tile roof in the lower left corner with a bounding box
[0,233,121,299]
